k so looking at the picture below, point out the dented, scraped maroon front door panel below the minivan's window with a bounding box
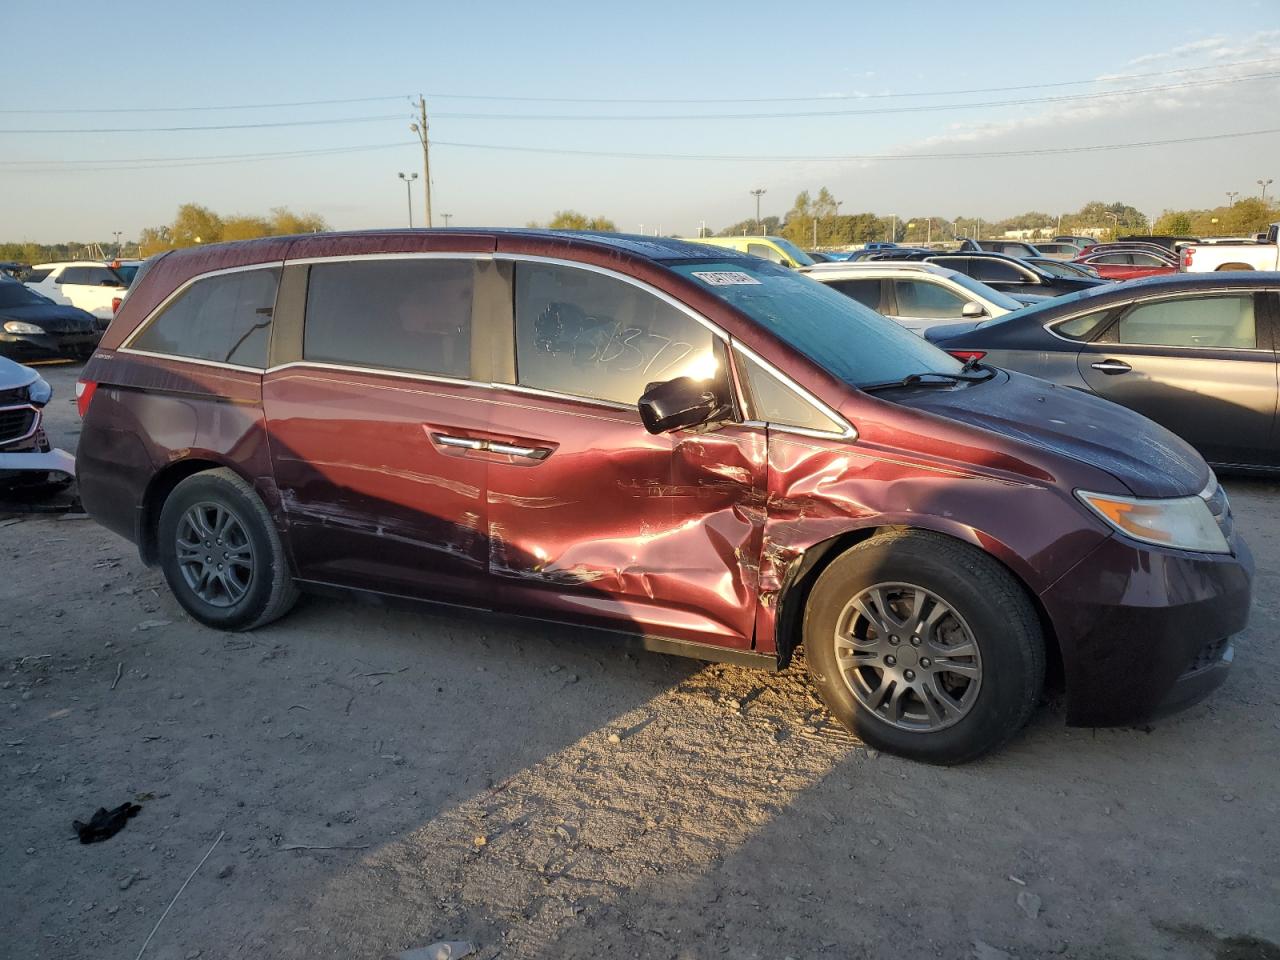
[488,390,767,649]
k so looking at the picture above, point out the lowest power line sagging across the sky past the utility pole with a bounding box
[0,128,1280,174]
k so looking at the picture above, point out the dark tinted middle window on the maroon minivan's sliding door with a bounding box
[302,259,475,380]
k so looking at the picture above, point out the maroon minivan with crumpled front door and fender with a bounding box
[78,230,1252,763]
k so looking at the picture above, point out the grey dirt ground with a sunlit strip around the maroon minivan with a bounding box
[0,367,1280,960]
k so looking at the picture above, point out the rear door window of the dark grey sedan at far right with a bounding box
[1116,294,1258,349]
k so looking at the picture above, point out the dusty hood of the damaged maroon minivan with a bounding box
[882,370,1211,497]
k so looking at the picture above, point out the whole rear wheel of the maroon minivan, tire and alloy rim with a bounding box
[157,468,298,630]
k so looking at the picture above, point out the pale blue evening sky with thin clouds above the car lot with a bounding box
[0,0,1280,243]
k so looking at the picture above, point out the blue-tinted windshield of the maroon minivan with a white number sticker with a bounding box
[671,259,963,387]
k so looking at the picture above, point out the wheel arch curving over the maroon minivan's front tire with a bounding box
[776,524,1064,689]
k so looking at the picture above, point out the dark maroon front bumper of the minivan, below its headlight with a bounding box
[1041,535,1253,726]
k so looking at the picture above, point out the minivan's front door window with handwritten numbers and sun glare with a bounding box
[516,261,727,406]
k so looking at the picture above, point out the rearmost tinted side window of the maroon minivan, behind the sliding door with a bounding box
[129,268,280,369]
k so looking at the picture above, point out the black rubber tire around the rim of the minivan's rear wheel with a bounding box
[156,468,298,630]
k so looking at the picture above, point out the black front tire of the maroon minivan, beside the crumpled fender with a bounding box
[804,530,1044,764]
